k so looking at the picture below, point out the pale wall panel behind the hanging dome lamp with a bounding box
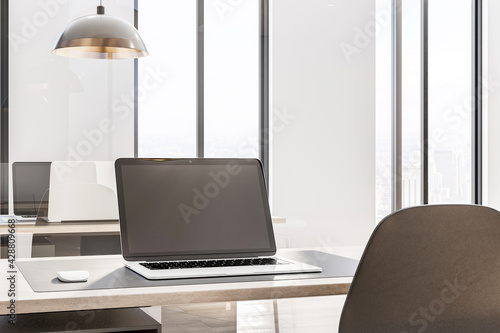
[8,0,134,213]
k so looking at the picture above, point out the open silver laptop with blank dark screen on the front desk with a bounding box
[115,158,321,279]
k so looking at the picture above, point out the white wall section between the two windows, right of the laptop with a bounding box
[271,0,375,247]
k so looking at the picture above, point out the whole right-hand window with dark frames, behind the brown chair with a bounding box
[377,0,482,218]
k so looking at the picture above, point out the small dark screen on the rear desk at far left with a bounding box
[12,162,50,215]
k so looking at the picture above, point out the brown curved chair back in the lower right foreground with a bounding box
[339,205,500,333]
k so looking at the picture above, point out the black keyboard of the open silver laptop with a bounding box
[141,258,289,270]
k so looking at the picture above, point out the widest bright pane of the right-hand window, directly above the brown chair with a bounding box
[428,0,472,204]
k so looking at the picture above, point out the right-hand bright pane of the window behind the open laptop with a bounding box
[205,0,260,158]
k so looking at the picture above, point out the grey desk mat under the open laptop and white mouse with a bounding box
[17,251,358,292]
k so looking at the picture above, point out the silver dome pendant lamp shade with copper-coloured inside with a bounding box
[52,14,149,59]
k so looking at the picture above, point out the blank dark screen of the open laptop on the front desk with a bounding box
[116,159,275,260]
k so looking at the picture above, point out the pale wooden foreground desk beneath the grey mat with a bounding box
[0,250,352,315]
